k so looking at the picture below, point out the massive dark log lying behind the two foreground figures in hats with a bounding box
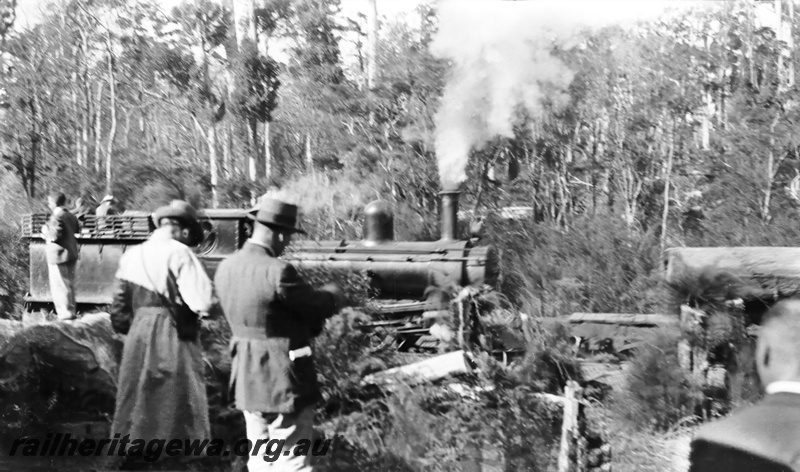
[0,313,230,428]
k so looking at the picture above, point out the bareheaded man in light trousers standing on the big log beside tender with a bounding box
[42,192,80,320]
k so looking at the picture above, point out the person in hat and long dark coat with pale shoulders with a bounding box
[111,200,213,468]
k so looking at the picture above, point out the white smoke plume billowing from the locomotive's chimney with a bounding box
[432,0,688,189]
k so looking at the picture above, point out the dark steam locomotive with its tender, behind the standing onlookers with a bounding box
[22,191,498,312]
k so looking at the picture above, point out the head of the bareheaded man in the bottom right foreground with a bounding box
[757,298,800,386]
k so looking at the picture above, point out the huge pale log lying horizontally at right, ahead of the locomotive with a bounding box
[665,247,800,299]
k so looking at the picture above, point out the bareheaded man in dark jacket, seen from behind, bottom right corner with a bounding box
[690,299,800,472]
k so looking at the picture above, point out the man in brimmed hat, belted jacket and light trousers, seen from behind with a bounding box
[214,197,343,472]
